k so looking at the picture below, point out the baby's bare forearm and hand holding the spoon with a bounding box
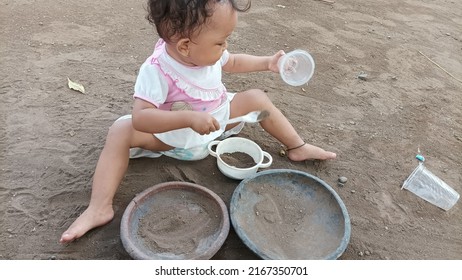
[128,98,220,135]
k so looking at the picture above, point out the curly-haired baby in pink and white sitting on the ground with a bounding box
[60,0,336,243]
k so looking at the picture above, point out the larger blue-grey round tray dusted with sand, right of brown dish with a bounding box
[230,169,351,260]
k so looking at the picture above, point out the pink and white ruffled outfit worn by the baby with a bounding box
[127,39,242,160]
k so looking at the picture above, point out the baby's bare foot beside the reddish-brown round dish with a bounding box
[59,207,114,244]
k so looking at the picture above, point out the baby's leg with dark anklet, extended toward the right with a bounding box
[230,89,337,161]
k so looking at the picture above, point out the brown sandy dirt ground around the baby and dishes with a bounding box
[0,0,462,260]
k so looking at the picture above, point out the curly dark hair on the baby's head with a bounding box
[146,0,251,42]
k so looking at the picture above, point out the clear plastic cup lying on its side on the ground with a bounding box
[401,163,460,211]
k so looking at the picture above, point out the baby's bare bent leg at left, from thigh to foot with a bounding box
[60,119,170,243]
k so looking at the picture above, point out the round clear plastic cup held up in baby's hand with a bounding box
[278,50,315,86]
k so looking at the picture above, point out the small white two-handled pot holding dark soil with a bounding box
[208,137,273,180]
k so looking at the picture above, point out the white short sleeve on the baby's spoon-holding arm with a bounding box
[133,60,168,107]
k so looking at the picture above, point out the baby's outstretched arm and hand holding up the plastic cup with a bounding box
[223,50,285,73]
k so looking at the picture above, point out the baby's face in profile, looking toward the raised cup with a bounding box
[189,2,237,66]
